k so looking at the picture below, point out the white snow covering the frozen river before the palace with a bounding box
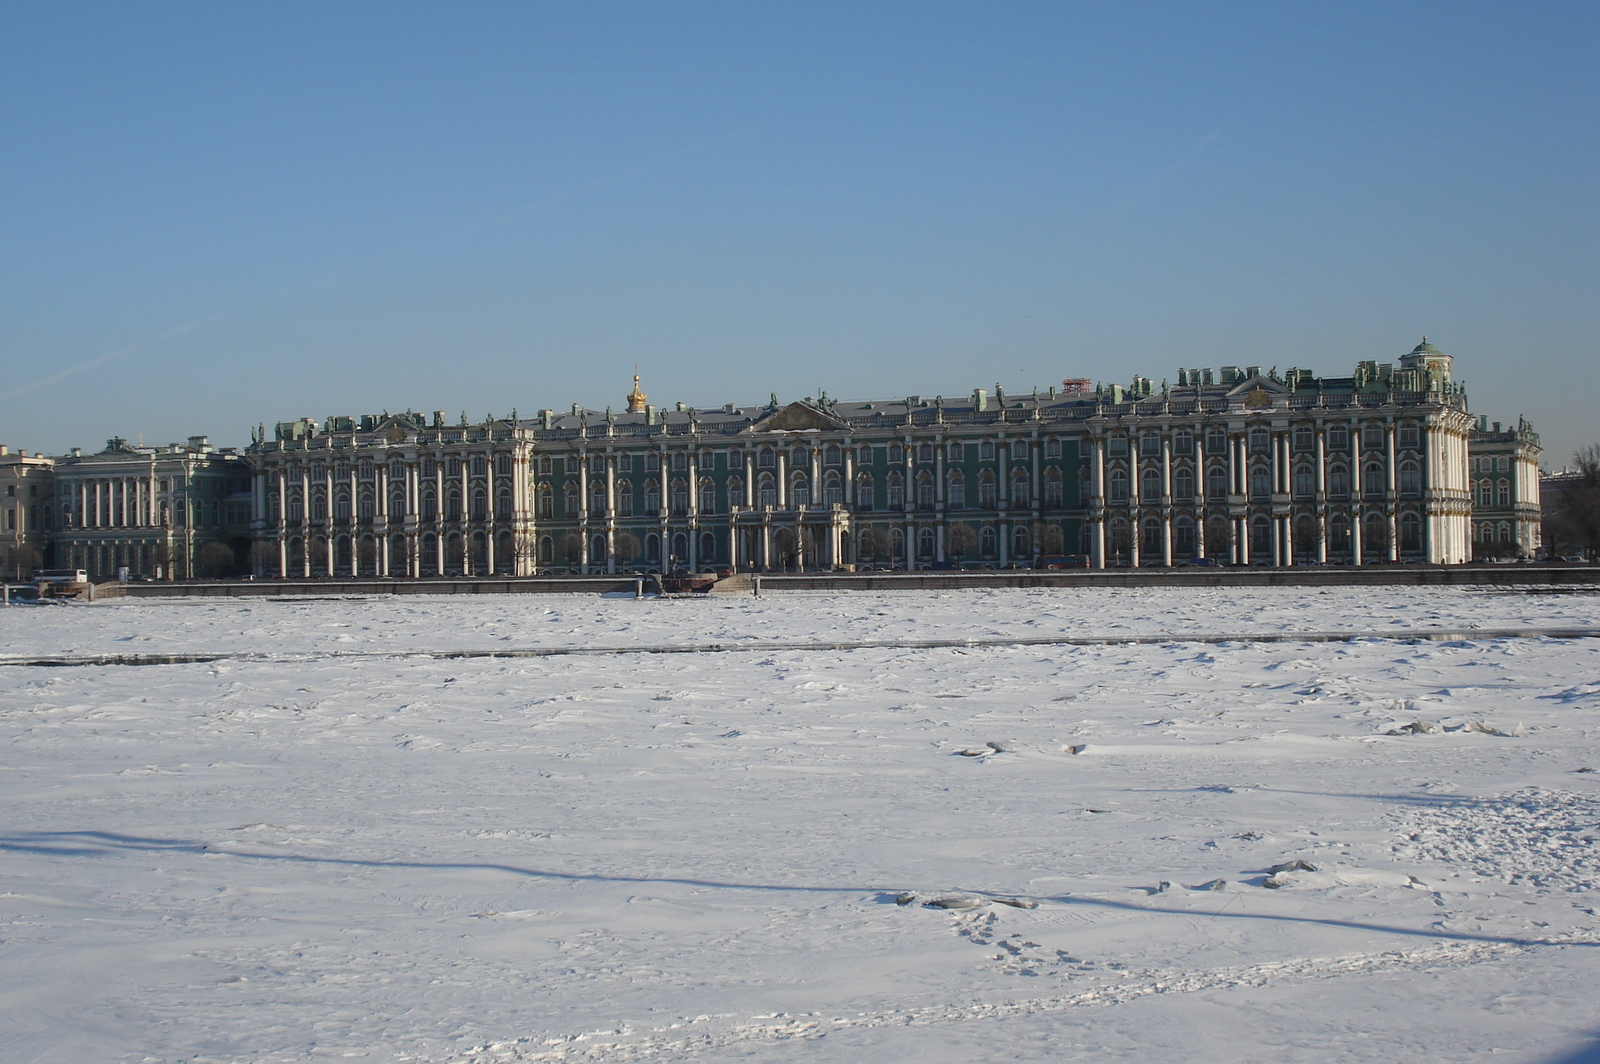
[0,587,1600,1064]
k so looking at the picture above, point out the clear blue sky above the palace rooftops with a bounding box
[0,0,1600,466]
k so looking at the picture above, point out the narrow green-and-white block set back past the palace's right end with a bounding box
[1467,416,1544,558]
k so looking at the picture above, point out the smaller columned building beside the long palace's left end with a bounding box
[54,435,250,581]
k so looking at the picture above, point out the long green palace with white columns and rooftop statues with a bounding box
[248,339,1474,576]
